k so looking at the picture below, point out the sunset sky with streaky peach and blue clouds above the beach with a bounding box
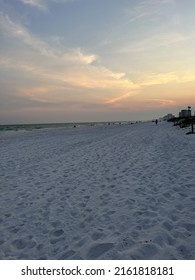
[0,0,195,124]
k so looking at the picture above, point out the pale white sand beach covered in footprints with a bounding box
[0,122,195,260]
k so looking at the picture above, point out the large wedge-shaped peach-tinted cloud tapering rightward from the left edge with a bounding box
[0,13,137,107]
